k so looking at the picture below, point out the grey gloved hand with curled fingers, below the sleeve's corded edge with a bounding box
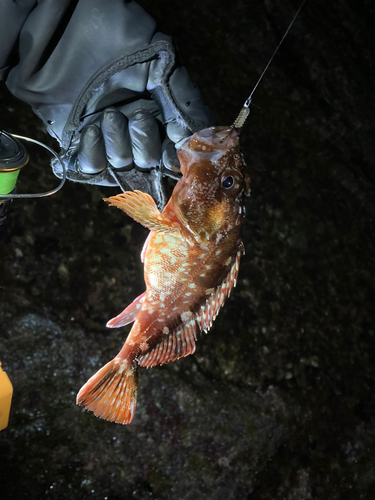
[54,33,213,207]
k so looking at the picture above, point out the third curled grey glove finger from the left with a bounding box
[129,109,161,170]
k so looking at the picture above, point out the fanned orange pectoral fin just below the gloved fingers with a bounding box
[104,190,179,233]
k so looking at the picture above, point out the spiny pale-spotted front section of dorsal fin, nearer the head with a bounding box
[197,242,244,333]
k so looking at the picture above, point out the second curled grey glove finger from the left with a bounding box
[101,108,133,170]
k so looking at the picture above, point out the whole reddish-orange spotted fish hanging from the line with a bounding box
[77,126,250,424]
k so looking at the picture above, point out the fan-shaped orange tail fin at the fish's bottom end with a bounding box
[77,357,137,424]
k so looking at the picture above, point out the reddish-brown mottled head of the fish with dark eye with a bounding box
[171,127,250,248]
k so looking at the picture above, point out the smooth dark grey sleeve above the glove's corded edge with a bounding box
[0,0,167,142]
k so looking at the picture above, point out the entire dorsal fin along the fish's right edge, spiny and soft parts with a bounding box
[139,243,244,368]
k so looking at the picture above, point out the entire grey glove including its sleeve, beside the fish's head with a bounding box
[0,0,212,206]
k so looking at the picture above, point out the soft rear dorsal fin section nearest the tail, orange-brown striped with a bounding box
[139,313,197,368]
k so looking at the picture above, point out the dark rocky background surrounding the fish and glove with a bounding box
[0,0,375,500]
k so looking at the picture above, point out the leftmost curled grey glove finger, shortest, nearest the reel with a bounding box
[78,125,107,174]
